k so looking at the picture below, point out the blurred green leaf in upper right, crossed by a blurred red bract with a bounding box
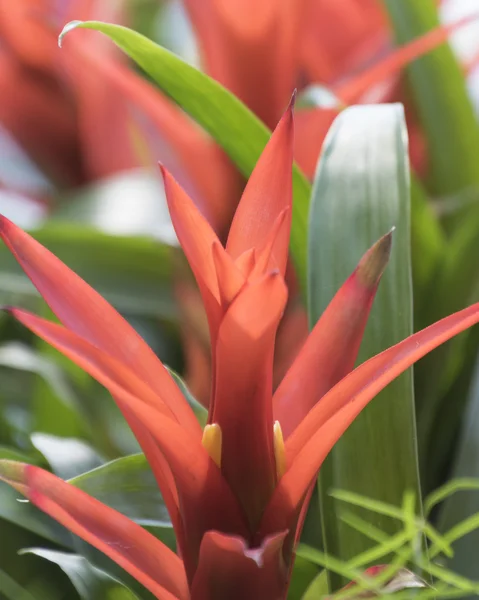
[383,0,479,195]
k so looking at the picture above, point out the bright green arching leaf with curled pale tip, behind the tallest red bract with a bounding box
[60,21,310,289]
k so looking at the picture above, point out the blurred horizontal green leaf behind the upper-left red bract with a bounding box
[0,223,177,319]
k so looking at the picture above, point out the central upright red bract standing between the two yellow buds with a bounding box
[214,273,287,531]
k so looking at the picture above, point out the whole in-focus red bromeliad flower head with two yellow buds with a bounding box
[0,106,479,600]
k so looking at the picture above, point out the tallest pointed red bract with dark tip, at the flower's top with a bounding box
[226,95,295,275]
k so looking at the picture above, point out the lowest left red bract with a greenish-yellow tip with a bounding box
[0,460,189,600]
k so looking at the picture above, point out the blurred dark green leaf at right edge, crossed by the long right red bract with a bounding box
[416,213,479,491]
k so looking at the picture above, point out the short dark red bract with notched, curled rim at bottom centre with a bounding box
[191,531,288,600]
